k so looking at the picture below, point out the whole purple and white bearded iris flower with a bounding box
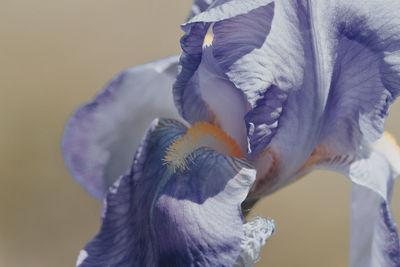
[63,0,400,267]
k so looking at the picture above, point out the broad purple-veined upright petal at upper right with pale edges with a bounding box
[321,1,400,153]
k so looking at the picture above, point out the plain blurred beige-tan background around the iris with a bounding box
[0,0,400,267]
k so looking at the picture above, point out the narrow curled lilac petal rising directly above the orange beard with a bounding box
[174,1,270,151]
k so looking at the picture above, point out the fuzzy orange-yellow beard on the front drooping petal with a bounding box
[163,122,243,171]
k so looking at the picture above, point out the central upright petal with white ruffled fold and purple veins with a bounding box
[220,0,333,198]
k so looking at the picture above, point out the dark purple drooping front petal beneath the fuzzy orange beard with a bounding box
[79,120,260,267]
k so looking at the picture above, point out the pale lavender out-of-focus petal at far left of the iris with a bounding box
[62,56,178,200]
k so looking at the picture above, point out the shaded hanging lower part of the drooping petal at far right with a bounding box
[349,184,400,267]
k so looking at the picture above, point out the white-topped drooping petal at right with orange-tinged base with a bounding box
[300,133,400,267]
